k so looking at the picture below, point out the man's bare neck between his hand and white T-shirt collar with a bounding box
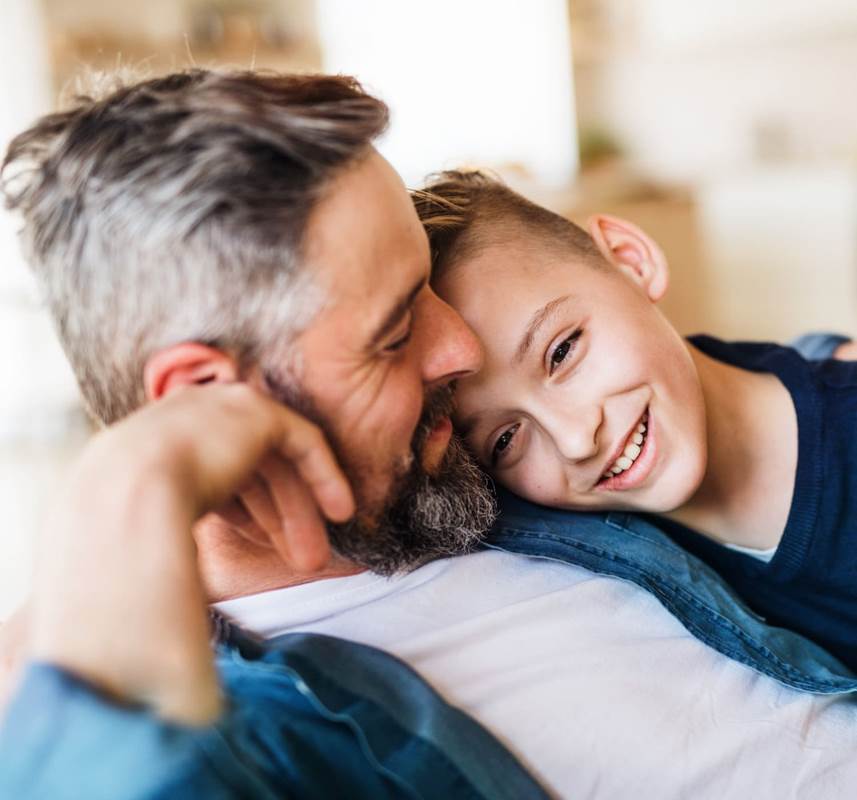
[194,516,365,603]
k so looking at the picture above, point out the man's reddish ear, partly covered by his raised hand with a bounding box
[143,342,238,400]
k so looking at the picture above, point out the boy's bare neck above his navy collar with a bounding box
[666,344,797,549]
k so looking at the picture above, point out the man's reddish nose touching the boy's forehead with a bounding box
[421,292,483,386]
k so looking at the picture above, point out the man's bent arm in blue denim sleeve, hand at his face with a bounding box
[0,385,546,800]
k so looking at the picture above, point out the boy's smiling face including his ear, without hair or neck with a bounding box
[435,218,707,511]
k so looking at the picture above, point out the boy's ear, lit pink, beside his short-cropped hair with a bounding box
[587,214,670,303]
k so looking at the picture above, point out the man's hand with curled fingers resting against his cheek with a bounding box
[111,383,355,571]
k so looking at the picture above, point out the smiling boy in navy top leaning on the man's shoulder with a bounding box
[415,172,857,668]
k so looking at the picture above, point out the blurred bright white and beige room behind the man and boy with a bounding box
[0,0,857,620]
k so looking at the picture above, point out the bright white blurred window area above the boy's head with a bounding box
[318,0,577,185]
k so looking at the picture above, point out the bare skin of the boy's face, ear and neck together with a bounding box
[435,215,797,548]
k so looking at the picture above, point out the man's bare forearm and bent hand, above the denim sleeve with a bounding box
[28,384,353,723]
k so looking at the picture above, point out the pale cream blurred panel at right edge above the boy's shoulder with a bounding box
[697,165,857,341]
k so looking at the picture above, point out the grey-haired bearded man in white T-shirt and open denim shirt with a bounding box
[0,72,857,798]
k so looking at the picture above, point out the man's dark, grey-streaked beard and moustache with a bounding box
[265,373,496,575]
